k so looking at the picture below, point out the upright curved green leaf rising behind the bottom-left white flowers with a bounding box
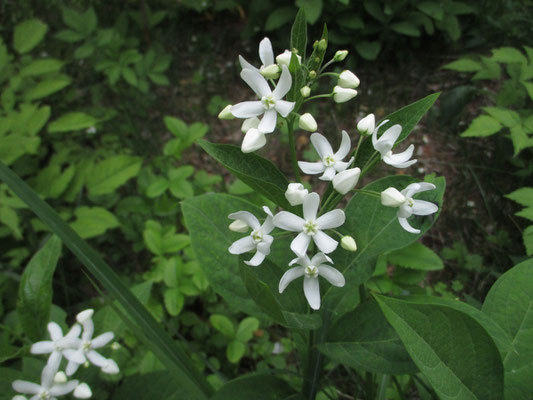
[17,236,61,342]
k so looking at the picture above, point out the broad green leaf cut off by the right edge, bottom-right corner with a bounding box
[482,259,533,400]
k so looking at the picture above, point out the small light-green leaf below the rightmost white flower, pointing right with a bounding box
[387,242,444,271]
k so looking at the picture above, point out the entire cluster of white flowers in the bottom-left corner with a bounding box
[12,309,119,400]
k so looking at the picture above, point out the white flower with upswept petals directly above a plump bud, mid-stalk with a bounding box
[298,131,354,181]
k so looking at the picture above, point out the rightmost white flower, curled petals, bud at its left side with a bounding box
[381,182,439,233]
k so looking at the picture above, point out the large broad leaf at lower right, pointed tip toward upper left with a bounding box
[375,295,503,400]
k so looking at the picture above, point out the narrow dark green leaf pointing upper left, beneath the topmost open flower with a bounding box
[198,140,291,210]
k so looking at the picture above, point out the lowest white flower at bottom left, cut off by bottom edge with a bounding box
[11,365,78,400]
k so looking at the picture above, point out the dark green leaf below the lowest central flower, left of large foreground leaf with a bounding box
[319,300,418,375]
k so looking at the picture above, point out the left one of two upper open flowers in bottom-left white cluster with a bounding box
[30,322,81,370]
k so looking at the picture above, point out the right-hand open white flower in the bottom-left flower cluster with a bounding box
[63,309,119,376]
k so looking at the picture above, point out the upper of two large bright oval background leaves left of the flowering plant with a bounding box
[86,154,142,196]
